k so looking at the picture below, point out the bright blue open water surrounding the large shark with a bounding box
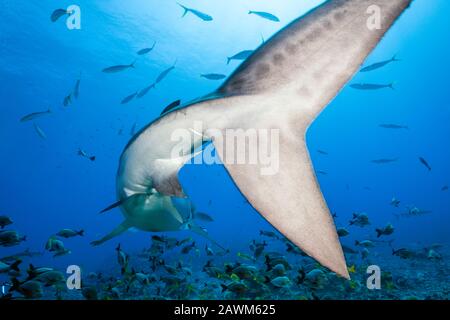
[0,0,450,300]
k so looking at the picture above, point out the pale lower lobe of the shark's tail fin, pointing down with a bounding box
[217,125,349,278]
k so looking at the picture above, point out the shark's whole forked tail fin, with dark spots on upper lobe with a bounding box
[211,0,412,278]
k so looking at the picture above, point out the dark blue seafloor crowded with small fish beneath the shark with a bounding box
[4,237,450,300]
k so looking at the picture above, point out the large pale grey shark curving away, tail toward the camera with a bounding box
[92,0,413,279]
